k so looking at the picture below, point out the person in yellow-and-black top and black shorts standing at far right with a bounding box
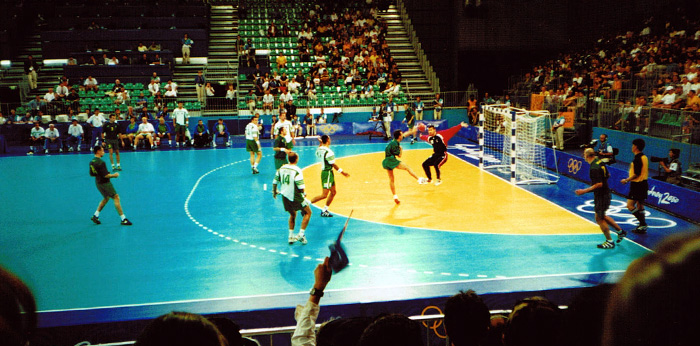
[620,138,649,233]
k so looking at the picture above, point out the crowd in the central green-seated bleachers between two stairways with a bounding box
[239,0,406,109]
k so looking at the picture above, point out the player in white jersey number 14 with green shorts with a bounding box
[272,151,311,245]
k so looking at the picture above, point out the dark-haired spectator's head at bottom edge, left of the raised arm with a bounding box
[135,312,228,346]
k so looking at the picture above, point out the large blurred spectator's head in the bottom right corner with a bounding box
[602,232,700,346]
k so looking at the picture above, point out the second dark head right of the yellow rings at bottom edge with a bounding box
[503,297,564,346]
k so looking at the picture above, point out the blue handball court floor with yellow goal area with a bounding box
[0,132,692,340]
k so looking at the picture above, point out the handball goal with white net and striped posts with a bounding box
[479,105,559,184]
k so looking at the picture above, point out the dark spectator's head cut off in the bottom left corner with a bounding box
[0,267,37,346]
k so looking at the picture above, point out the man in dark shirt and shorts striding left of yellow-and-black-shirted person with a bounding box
[574,148,627,249]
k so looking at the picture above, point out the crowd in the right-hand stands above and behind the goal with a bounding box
[511,15,700,138]
